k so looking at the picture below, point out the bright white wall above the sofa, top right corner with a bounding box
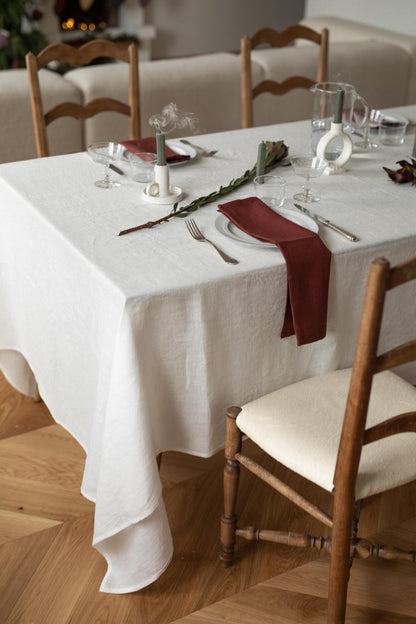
[305,0,416,35]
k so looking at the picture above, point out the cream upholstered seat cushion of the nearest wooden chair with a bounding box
[237,369,416,500]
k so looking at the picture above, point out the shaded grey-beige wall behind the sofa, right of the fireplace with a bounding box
[145,0,304,58]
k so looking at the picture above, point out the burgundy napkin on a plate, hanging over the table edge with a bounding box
[218,197,331,346]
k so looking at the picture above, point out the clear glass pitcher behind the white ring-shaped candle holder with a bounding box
[310,82,368,160]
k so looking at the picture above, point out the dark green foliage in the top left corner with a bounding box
[0,0,48,69]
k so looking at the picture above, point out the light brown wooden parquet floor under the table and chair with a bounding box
[0,370,416,624]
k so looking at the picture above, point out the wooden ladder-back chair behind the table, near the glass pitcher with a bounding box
[241,24,329,128]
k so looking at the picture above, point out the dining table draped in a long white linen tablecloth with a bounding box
[0,106,416,593]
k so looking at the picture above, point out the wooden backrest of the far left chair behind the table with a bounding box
[26,39,141,157]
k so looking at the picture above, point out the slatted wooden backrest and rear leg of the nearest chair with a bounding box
[328,256,416,622]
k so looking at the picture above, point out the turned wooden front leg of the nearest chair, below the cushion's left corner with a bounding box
[220,407,242,568]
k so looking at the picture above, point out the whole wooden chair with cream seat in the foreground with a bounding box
[221,256,416,624]
